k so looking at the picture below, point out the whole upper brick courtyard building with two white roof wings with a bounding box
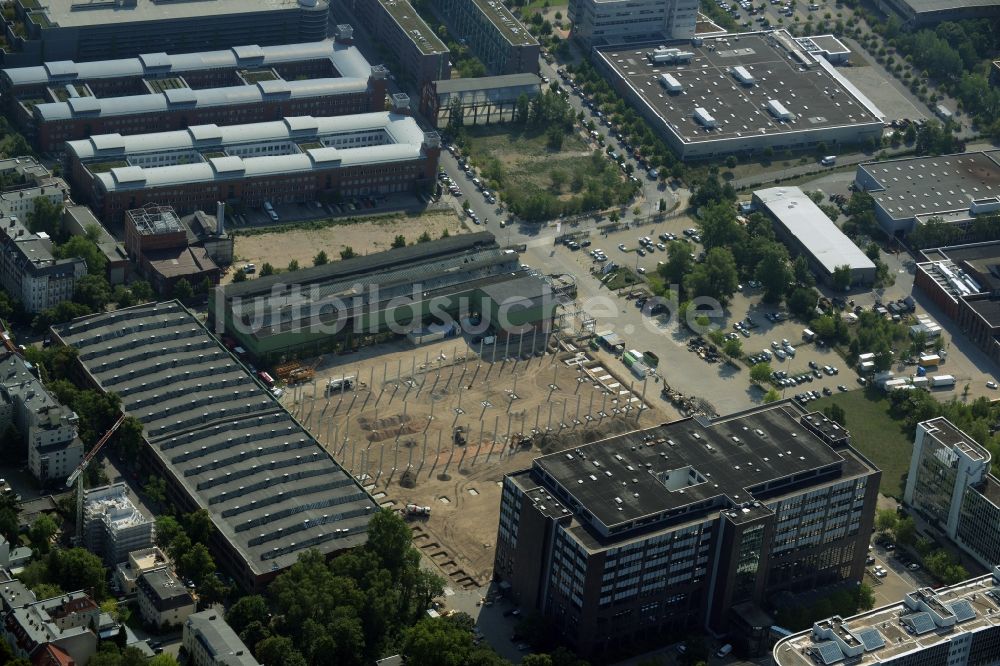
[0,40,388,152]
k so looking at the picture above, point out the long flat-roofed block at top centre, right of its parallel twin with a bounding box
[432,0,539,74]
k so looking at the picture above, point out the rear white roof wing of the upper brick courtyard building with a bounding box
[3,39,371,86]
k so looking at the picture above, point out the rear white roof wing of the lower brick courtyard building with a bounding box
[66,111,424,161]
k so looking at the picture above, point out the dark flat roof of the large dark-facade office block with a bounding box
[534,402,844,528]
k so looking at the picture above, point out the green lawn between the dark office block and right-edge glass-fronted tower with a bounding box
[810,389,913,499]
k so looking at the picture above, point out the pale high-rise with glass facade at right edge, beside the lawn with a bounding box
[903,416,1000,567]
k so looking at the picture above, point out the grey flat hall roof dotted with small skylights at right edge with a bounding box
[859,152,1000,219]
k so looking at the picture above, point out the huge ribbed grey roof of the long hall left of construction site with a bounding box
[53,301,378,574]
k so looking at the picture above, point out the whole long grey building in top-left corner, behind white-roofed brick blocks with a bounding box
[2,0,330,67]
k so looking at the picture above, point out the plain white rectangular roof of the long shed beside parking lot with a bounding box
[754,187,875,274]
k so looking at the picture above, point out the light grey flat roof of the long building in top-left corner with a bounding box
[37,0,328,27]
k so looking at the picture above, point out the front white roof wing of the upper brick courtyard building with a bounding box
[35,77,368,122]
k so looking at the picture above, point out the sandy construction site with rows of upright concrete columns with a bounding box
[281,337,678,588]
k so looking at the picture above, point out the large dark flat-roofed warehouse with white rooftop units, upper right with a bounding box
[594,30,884,159]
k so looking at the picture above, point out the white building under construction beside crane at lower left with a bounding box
[83,483,153,567]
